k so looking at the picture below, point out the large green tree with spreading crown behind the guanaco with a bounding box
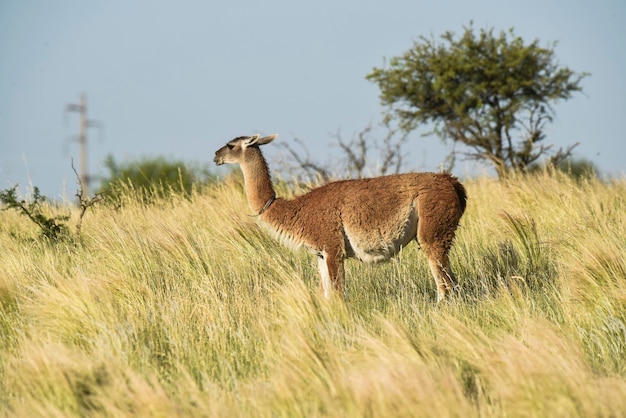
[367,24,588,177]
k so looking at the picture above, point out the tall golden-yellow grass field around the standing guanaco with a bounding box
[0,173,626,417]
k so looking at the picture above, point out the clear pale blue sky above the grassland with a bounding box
[0,0,626,198]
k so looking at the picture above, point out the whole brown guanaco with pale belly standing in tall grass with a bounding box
[215,135,467,299]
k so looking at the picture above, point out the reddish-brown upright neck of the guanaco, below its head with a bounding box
[241,147,276,215]
